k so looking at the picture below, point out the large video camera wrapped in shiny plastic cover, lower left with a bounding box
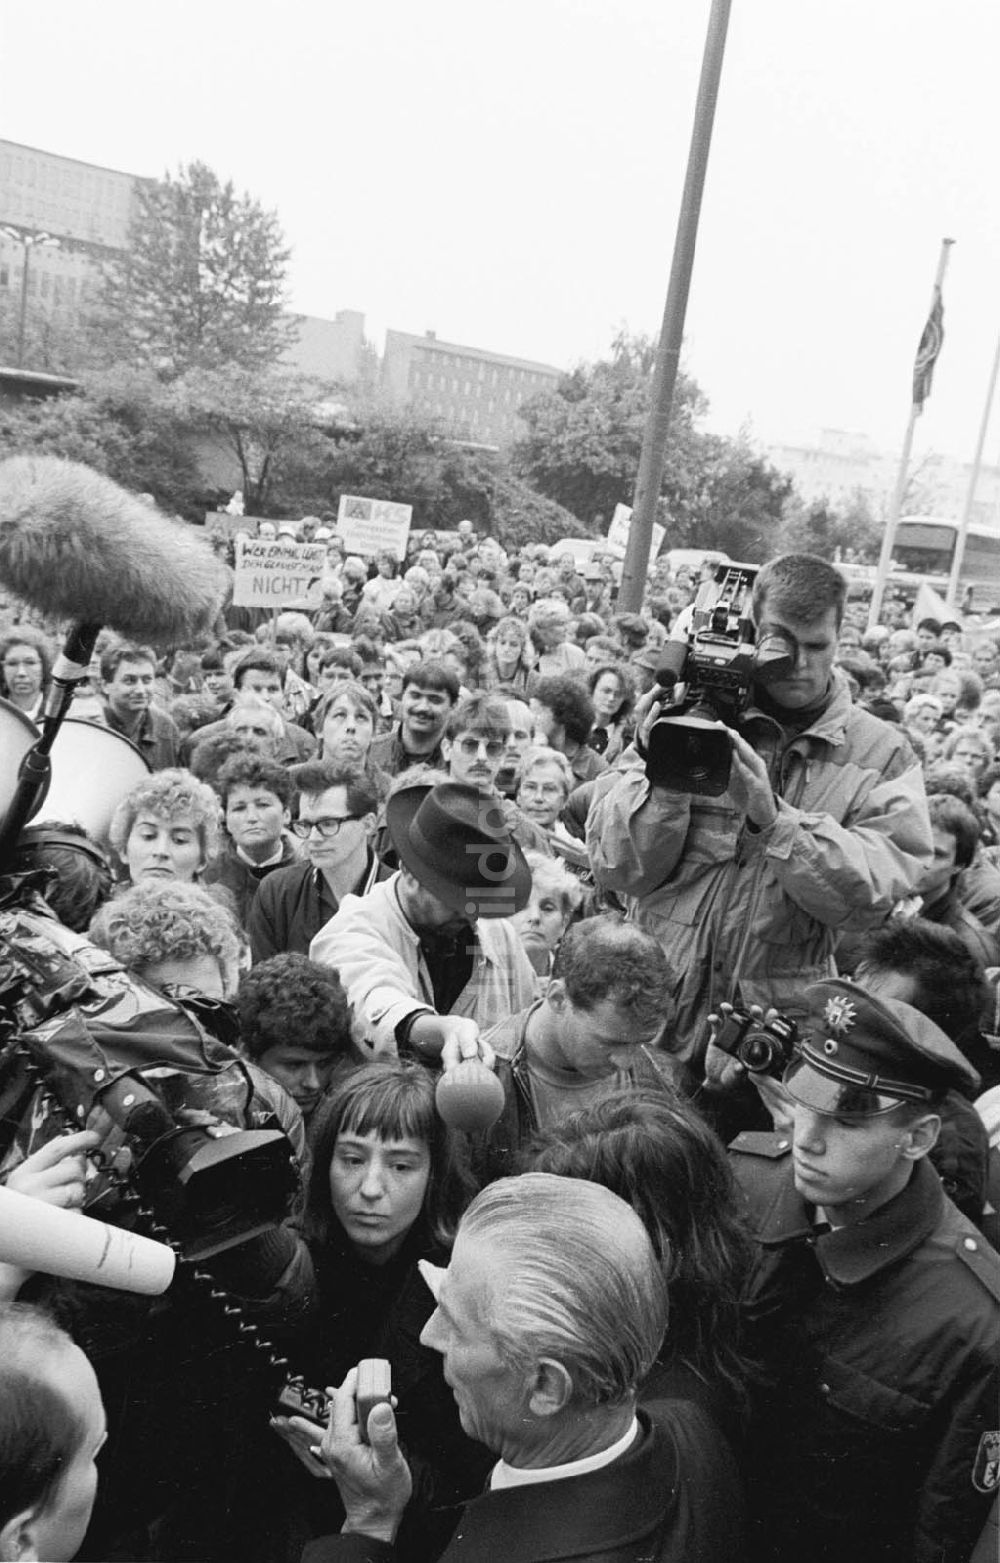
[0,899,297,1263]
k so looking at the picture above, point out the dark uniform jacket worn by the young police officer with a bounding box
[731,1135,1000,1563]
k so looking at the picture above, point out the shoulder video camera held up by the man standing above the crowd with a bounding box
[645,564,795,797]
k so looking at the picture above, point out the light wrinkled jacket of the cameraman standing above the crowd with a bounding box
[588,669,933,1060]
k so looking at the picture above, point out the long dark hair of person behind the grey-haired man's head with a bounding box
[522,1089,752,1446]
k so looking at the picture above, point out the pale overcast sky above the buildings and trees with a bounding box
[0,0,1000,461]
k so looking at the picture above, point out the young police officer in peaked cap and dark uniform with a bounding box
[731,980,1000,1563]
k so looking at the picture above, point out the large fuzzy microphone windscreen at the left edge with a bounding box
[0,456,228,646]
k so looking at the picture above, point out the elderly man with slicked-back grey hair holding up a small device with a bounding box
[293,1172,741,1563]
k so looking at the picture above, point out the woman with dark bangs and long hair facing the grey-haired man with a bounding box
[268,1060,495,1558]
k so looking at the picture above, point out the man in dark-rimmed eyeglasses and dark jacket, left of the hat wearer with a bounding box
[247,760,386,963]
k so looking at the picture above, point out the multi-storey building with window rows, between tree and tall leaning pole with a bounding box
[381,331,561,447]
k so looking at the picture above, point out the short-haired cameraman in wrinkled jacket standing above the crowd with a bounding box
[588,553,931,1077]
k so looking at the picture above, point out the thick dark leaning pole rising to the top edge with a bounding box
[619,0,731,613]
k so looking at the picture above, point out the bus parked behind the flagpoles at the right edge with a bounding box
[889,516,1000,613]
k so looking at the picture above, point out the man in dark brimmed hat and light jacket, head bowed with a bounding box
[309,782,536,1068]
